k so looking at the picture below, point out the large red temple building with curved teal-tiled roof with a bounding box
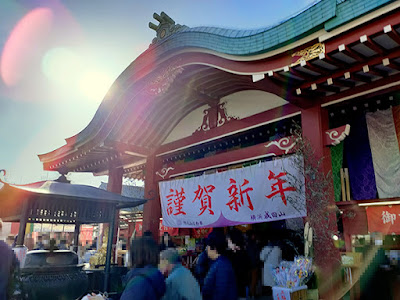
[39,0,400,296]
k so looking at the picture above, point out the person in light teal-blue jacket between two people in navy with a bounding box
[160,248,201,300]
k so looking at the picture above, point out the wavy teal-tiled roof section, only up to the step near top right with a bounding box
[152,0,336,55]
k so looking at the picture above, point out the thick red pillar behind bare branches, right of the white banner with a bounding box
[301,104,340,299]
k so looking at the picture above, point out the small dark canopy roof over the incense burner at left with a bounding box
[0,177,146,224]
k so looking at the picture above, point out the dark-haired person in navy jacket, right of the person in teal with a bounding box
[202,231,237,300]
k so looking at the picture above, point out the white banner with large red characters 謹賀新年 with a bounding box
[159,156,306,228]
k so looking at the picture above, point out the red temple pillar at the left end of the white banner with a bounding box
[143,155,161,242]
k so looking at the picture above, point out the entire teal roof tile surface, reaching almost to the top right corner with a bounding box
[152,0,393,56]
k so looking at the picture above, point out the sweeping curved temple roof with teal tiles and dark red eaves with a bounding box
[39,0,398,174]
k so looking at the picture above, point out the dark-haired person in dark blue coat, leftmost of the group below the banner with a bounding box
[120,236,165,300]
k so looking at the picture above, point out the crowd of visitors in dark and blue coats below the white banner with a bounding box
[121,228,280,300]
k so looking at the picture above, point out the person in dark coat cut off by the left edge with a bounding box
[0,219,18,300]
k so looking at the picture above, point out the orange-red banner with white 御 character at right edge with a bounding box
[366,205,400,234]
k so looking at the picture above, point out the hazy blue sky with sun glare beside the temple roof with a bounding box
[0,0,316,186]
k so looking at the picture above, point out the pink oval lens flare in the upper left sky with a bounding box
[0,7,53,86]
